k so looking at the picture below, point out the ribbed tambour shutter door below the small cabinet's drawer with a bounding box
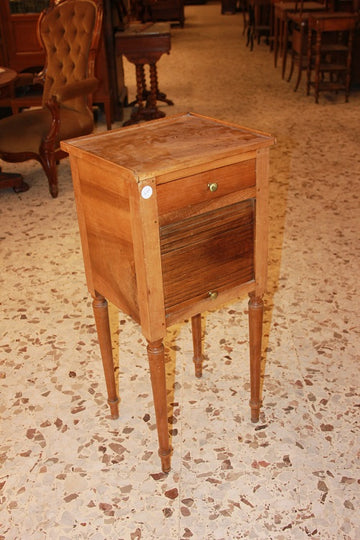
[160,199,255,314]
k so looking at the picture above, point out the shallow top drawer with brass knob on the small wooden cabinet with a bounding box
[157,158,256,216]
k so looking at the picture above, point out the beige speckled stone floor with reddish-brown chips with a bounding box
[0,3,360,540]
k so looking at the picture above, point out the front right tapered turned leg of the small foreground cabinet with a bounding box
[249,293,264,422]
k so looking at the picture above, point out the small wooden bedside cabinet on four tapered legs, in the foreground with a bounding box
[61,114,274,472]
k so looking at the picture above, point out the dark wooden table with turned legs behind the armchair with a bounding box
[115,23,173,125]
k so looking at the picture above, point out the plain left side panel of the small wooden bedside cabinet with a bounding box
[74,159,139,321]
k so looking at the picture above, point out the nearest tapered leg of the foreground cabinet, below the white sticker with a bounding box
[147,340,171,473]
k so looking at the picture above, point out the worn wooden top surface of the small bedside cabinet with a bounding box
[61,113,275,180]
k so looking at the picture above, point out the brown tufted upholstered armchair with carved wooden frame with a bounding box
[0,0,102,197]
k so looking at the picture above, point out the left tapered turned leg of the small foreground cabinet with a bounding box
[93,294,119,419]
